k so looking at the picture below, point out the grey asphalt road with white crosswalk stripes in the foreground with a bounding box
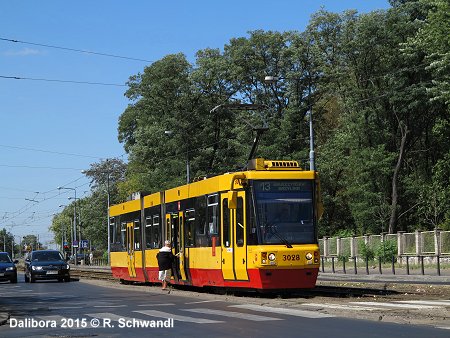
[0,275,450,338]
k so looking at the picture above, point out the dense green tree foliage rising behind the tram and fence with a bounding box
[51,0,450,248]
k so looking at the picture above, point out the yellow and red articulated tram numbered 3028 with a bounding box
[109,158,322,290]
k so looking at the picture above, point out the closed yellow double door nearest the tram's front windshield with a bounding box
[221,192,248,280]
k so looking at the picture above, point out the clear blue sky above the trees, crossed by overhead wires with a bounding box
[0,0,389,249]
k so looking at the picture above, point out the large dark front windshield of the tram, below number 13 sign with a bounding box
[253,180,316,246]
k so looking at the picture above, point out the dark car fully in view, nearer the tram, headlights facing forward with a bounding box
[25,250,70,283]
